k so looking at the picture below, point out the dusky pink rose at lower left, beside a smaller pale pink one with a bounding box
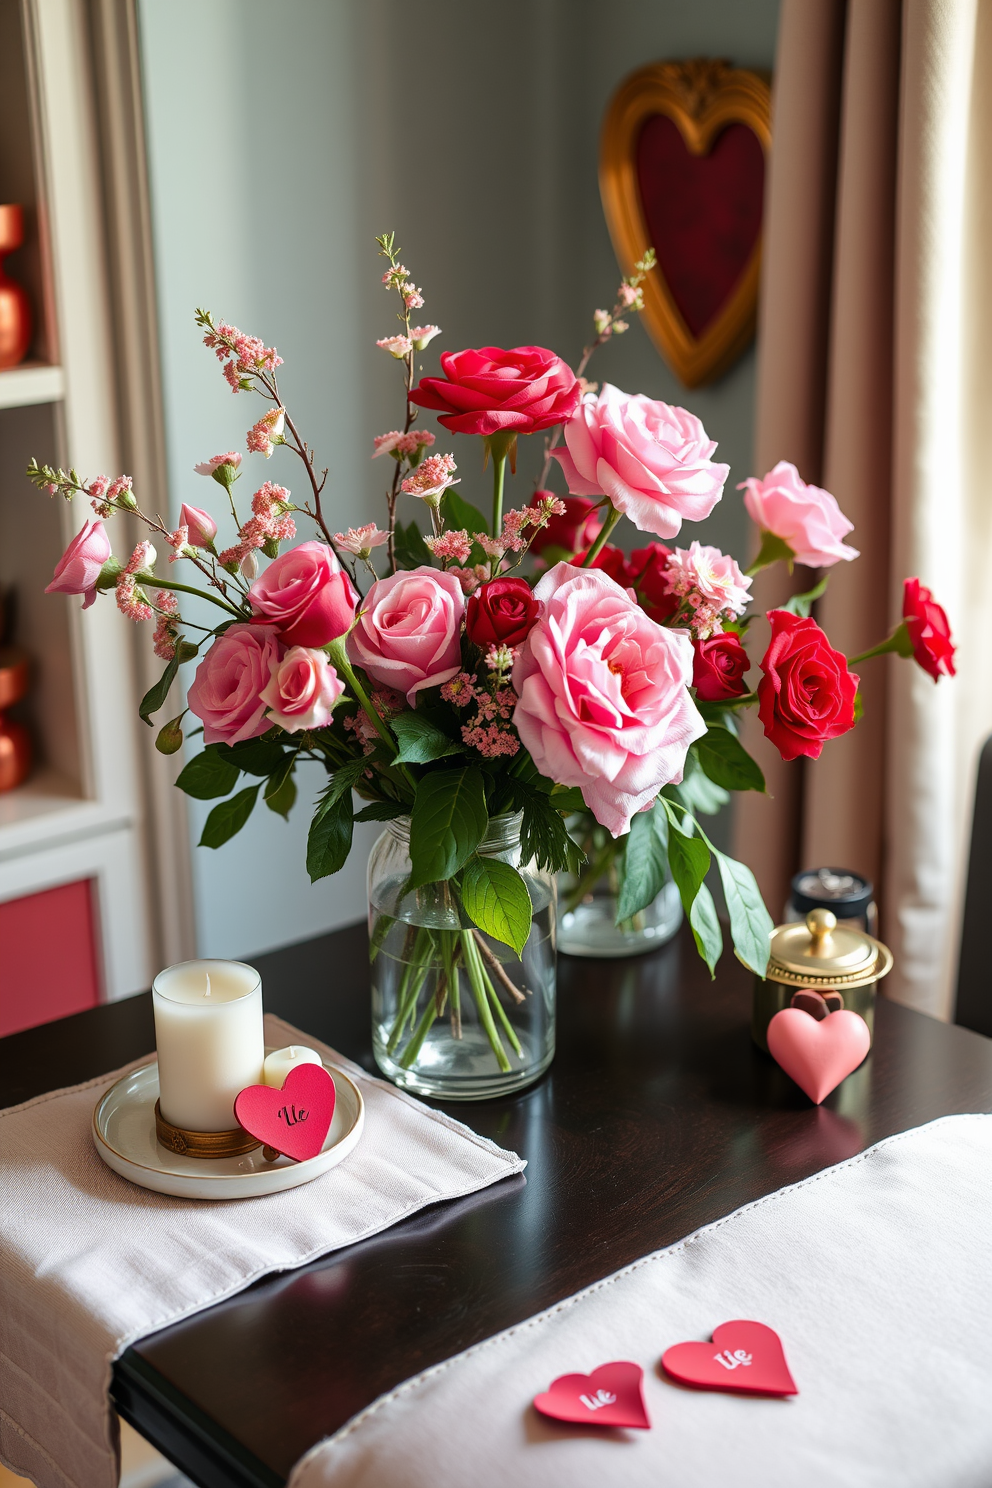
[186,625,280,744]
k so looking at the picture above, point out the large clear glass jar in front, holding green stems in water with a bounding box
[369,815,556,1101]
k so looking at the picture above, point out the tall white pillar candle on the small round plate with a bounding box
[152,961,265,1131]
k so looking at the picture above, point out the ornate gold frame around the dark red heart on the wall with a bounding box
[599,58,772,387]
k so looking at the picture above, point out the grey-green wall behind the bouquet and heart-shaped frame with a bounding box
[140,0,778,955]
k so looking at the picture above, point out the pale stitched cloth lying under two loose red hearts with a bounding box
[289,1116,992,1488]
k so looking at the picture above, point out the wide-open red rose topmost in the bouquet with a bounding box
[410,347,580,434]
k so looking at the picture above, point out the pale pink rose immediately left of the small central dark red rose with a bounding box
[348,567,466,707]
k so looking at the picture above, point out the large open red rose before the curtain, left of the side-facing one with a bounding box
[757,610,858,759]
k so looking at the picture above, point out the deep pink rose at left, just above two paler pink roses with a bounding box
[248,542,358,646]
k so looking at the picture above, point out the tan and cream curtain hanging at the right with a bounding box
[736,0,992,1016]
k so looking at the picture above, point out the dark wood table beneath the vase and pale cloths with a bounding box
[0,927,992,1488]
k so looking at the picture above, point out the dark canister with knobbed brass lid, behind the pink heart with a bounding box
[751,909,892,1052]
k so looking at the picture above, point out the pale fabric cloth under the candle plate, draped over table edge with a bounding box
[0,1016,525,1488]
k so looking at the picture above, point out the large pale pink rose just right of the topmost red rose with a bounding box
[552,382,730,537]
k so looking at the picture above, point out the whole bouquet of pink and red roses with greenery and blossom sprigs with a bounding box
[28,234,953,1068]
